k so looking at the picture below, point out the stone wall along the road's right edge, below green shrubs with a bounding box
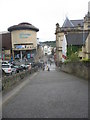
[60,62,90,80]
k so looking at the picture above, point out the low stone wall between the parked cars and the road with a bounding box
[2,68,38,92]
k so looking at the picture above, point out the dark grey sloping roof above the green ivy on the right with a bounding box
[66,32,88,45]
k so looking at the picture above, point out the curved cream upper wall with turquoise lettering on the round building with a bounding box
[11,30,37,48]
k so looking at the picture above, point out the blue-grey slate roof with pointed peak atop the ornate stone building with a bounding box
[62,17,83,28]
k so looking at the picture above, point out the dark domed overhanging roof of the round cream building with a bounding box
[8,22,39,32]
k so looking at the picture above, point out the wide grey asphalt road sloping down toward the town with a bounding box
[2,65,88,118]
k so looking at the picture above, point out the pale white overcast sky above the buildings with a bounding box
[0,0,89,42]
